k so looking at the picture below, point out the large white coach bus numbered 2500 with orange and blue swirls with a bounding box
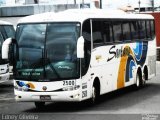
[3,9,156,108]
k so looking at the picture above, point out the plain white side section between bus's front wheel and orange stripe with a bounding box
[91,46,119,94]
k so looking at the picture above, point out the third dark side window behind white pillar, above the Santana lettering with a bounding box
[112,21,123,42]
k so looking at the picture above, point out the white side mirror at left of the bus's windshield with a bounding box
[2,38,12,59]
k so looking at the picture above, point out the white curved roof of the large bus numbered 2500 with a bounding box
[18,9,154,23]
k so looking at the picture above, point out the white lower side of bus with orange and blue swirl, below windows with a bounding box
[91,38,155,94]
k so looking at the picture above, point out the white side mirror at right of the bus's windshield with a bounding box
[77,36,84,58]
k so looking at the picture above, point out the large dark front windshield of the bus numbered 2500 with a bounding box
[15,23,80,81]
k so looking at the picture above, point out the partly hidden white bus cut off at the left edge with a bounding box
[0,20,15,83]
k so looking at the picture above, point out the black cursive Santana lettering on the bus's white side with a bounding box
[107,45,131,62]
